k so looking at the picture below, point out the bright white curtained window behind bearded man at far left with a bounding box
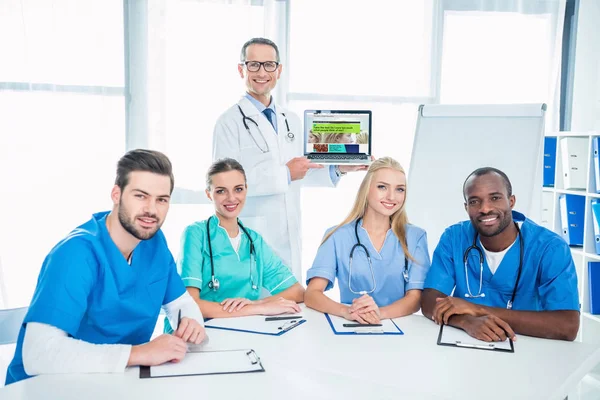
[0,0,125,307]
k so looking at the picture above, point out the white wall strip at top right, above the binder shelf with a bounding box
[571,0,600,131]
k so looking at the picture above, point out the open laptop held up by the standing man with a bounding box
[304,110,372,165]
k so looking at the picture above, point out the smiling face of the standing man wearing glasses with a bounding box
[238,44,282,99]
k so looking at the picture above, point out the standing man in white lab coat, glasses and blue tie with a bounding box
[213,38,367,280]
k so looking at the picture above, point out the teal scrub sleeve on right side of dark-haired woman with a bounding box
[254,235,298,295]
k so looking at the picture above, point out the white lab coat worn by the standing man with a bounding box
[213,97,334,281]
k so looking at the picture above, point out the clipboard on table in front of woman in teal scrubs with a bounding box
[204,315,306,336]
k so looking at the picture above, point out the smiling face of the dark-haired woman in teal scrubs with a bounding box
[206,170,246,220]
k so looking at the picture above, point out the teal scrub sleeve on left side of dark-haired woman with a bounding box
[177,224,204,290]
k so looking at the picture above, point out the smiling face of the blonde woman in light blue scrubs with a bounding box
[367,168,406,217]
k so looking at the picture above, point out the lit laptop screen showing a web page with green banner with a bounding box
[304,110,371,154]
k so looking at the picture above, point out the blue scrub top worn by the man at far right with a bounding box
[425,211,579,311]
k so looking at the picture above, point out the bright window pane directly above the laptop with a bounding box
[288,0,432,97]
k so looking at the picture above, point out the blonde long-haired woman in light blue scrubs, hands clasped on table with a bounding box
[305,157,431,324]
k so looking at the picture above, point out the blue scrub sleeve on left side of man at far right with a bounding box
[424,229,456,296]
